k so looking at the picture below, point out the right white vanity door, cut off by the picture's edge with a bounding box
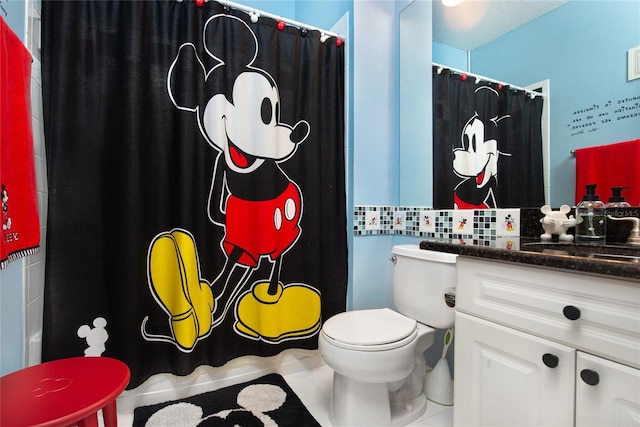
[576,352,640,427]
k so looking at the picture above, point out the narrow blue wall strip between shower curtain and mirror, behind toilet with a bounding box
[348,1,397,309]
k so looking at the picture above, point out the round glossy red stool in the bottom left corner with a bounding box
[0,357,131,427]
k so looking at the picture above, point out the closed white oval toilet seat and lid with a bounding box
[322,308,418,351]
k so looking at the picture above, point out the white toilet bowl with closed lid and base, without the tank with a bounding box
[318,308,434,426]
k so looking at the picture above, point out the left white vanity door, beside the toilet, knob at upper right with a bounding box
[453,313,575,427]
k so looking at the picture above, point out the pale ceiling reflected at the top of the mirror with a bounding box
[433,0,567,50]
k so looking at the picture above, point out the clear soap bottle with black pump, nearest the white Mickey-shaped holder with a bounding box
[576,184,607,245]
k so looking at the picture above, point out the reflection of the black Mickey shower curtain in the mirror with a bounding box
[432,67,544,209]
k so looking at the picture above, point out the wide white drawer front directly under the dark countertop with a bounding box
[456,256,640,368]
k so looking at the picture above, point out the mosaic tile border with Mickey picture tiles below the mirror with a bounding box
[353,206,520,240]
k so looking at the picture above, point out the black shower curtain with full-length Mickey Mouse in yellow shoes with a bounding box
[42,1,347,388]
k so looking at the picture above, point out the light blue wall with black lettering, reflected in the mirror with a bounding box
[471,0,640,206]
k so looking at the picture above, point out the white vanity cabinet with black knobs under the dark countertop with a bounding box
[454,256,640,426]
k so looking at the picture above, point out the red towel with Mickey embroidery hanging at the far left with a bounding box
[0,18,40,268]
